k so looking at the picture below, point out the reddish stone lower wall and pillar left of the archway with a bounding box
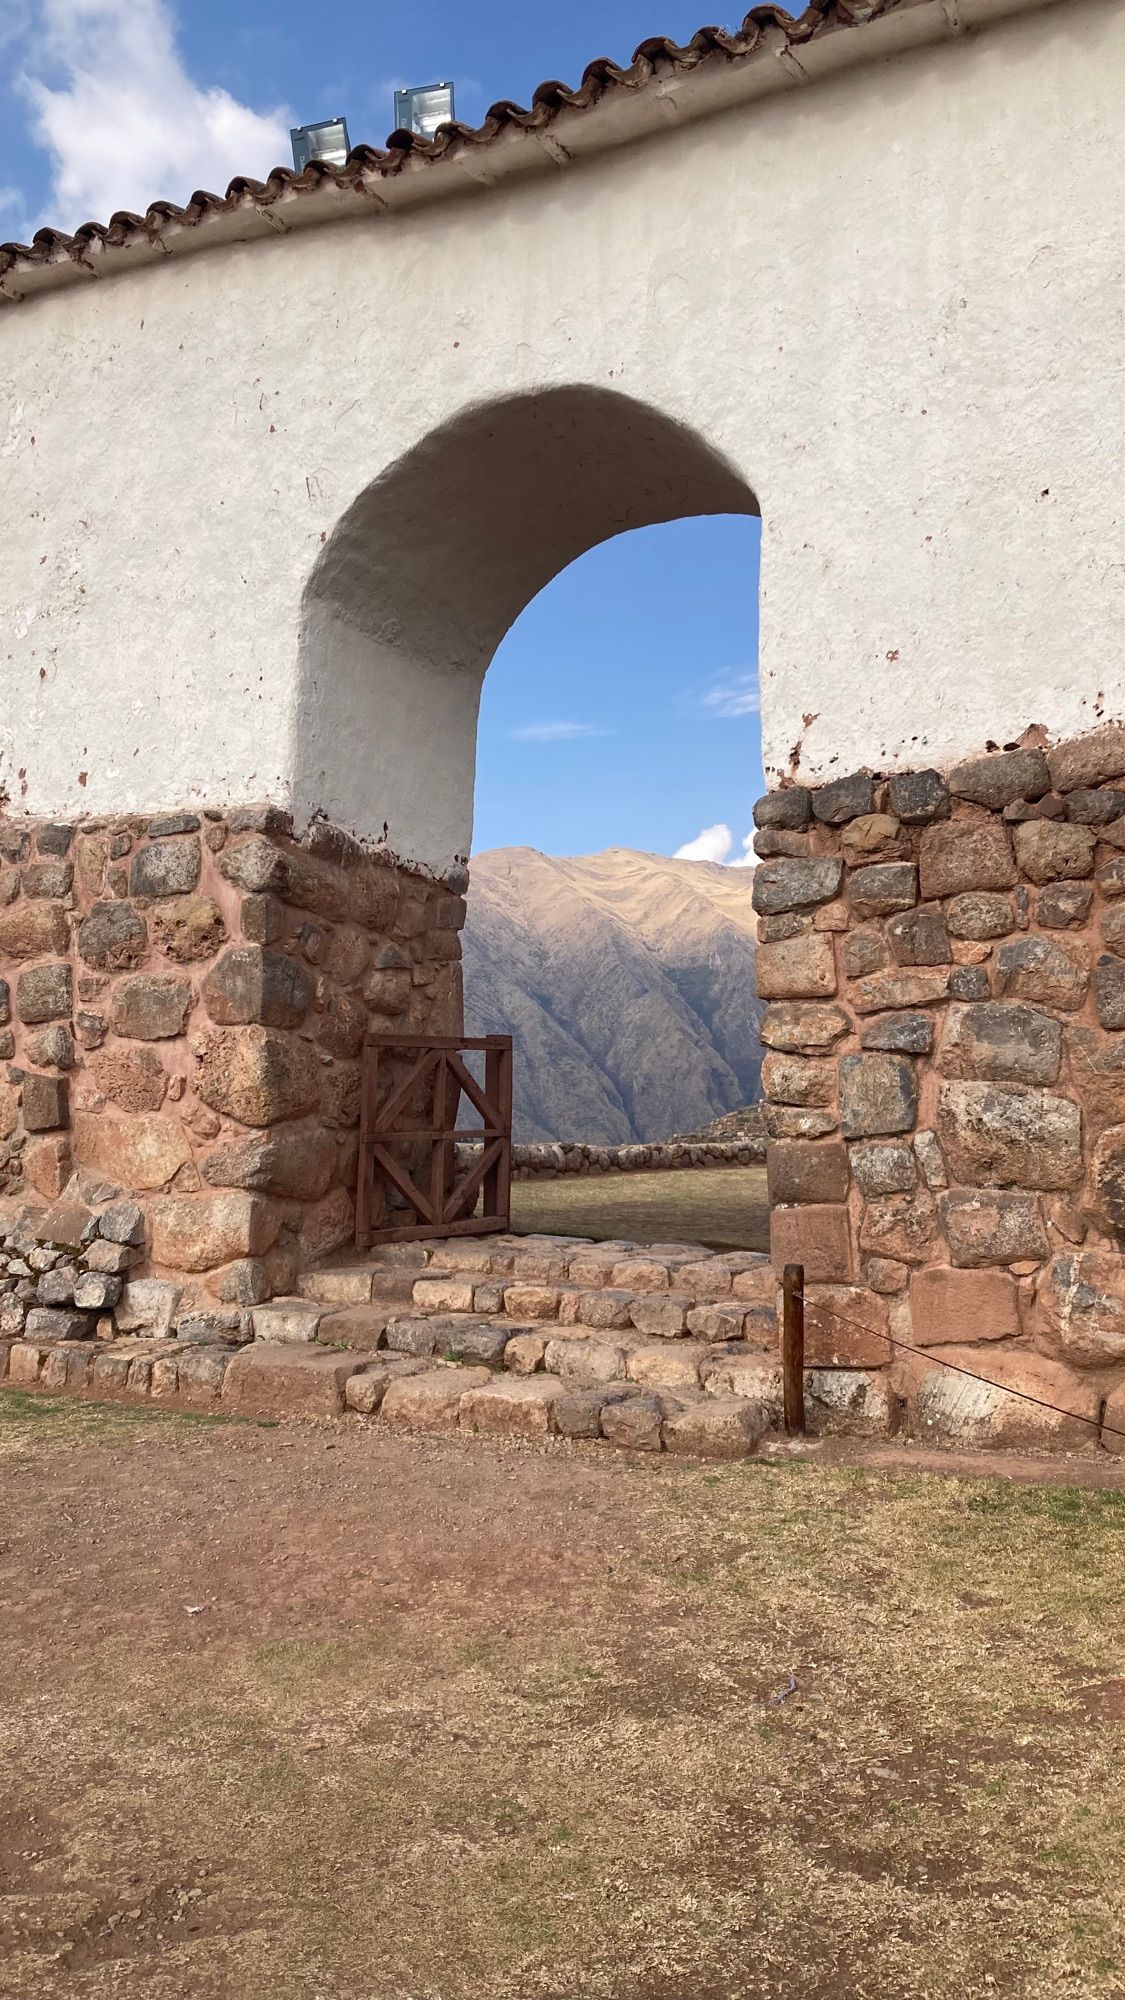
[0,808,464,1304]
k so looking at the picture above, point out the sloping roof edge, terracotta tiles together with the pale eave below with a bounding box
[0,0,1061,304]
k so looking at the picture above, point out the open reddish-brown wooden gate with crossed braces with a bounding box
[356,1034,512,1250]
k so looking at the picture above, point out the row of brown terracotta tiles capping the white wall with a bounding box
[0,0,921,296]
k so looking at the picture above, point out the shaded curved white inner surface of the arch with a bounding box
[294,386,759,874]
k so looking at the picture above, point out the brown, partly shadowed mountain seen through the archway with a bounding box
[464,848,763,1146]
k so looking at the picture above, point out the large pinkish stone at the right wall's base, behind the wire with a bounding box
[903,1346,1101,1452]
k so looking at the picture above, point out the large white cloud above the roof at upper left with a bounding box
[16,0,290,230]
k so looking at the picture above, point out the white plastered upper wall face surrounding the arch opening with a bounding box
[0,0,1125,866]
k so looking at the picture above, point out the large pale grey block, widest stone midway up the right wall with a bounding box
[937,1082,1083,1188]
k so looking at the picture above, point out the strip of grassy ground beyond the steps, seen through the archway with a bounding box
[512,1166,769,1250]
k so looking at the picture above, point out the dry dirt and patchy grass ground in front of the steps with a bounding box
[0,1394,1125,2000]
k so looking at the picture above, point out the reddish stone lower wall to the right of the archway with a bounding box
[755,724,1125,1406]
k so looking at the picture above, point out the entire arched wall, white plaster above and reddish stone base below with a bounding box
[0,0,1125,1440]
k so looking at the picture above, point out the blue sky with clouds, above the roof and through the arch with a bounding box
[0,0,763,860]
